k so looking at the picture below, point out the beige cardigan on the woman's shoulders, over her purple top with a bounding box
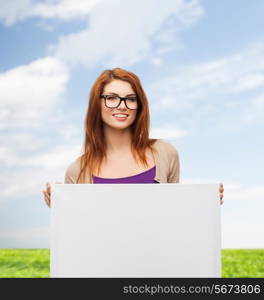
[64,139,180,183]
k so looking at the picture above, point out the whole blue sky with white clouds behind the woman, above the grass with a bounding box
[0,0,264,248]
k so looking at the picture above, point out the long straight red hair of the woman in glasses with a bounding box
[77,68,157,183]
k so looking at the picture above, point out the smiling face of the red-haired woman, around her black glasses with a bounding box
[101,79,137,129]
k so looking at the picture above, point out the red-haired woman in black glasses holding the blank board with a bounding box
[43,68,224,207]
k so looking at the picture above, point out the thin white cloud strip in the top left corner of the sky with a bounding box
[0,0,102,26]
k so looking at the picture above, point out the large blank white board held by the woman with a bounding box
[50,183,221,278]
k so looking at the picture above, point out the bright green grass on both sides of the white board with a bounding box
[0,249,264,278]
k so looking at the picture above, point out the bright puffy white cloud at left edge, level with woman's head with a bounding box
[0,57,69,129]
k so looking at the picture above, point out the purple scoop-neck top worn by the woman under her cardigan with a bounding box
[93,166,158,183]
